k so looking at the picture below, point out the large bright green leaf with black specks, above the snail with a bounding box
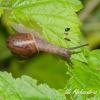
[7,0,87,62]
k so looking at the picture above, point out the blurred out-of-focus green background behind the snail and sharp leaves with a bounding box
[0,0,100,89]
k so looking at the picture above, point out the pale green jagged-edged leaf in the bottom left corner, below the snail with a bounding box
[0,72,66,100]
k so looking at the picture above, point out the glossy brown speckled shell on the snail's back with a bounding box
[6,33,39,59]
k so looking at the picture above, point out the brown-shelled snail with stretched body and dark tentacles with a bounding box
[6,22,88,65]
